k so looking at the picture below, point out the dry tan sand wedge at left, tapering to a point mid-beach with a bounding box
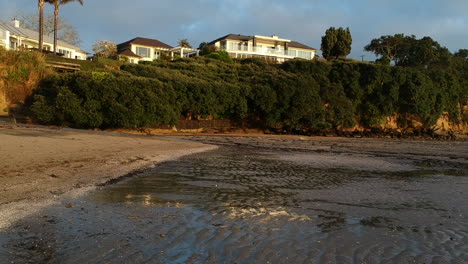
[0,125,216,229]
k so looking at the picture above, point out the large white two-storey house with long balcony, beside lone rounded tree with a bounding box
[208,34,317,63]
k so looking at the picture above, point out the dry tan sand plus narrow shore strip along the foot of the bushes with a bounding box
[0,124,466,230]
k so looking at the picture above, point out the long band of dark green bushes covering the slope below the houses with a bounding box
[28,57,468,133]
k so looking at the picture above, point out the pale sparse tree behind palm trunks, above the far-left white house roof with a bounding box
[16,13,81,45]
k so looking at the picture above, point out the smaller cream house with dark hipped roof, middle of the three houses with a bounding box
[117,37,196,63]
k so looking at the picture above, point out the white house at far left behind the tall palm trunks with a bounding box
[0,19,87,60]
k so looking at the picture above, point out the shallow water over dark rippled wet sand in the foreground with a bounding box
[0,147,468,263]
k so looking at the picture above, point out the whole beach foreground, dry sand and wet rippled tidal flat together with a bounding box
[0,126,468,263]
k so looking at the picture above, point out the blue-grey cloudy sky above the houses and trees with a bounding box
[0,0,468,60]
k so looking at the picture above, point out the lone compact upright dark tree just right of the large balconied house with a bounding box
[321,27,353,59]
